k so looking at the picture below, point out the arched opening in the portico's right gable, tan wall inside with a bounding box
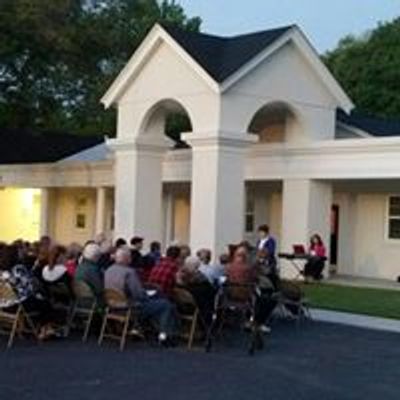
[248,102,301,143]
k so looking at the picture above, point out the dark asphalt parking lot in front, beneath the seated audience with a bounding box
[0,322,400,400]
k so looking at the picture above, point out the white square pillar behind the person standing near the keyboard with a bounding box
[281,179,332,276]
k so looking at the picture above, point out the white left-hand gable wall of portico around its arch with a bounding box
[117,43,220,139]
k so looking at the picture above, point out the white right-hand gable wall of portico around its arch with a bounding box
[221,44,338,143]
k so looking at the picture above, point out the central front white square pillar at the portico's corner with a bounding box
[184,132,256,257]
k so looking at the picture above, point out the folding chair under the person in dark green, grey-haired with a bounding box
[70,280,98,342]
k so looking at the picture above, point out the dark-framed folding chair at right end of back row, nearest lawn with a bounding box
[206,283,264,355]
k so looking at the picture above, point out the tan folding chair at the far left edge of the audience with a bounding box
[0,280,38,348]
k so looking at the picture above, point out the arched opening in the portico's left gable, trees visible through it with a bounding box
[141,99,193,149]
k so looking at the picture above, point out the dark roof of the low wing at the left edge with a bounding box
[0,129,104,164]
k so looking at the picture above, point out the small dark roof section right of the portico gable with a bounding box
[337,109,400,137]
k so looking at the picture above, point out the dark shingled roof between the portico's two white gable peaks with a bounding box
[163,25,293,83]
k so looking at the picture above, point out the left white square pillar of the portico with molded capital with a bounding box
[108,135,169,242]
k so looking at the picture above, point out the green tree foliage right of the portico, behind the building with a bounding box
[324,18,400,118]
